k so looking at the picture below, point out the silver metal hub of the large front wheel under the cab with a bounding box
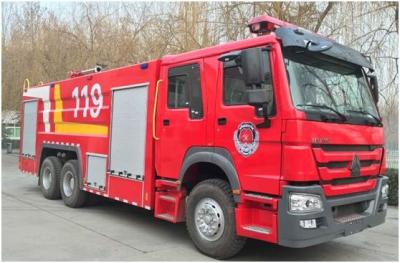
[195,198,225,241]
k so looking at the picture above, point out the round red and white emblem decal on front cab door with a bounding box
[233,122,259,157]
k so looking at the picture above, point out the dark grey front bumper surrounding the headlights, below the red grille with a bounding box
[278,177,388,248]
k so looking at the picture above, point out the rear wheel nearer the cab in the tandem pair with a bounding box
[60,160,88,208]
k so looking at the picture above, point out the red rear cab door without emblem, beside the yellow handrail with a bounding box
[156,60,207,179]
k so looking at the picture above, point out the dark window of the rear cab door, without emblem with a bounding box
[167,64,203,119]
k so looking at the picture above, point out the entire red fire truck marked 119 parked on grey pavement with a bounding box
[19,16,388,259]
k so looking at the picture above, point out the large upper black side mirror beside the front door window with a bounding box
[240,48,265,86]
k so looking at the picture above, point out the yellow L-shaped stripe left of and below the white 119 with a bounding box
[54,84,108,136]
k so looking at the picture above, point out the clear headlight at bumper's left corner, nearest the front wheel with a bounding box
[289,193,323,213]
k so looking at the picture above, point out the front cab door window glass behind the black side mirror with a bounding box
[223,48,275,116]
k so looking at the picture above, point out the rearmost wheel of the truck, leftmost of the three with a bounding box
[39,156,62,200]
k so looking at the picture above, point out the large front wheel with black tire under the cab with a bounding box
[186,179,246,259]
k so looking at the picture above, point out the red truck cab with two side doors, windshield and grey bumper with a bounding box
[156,16,388,254]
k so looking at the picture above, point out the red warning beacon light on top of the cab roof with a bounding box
[247,15,298,36]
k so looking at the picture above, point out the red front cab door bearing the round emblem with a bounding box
[215,48,282,197]
